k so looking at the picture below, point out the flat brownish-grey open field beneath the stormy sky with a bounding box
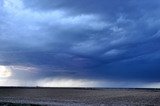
[0,87,160,106]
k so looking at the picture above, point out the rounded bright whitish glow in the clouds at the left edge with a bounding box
[0,66,12,78]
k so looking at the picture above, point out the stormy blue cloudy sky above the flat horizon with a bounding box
[0,0,160,88]
